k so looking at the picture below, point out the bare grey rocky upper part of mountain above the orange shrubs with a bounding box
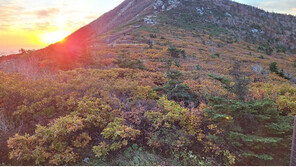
[44,0,296,51]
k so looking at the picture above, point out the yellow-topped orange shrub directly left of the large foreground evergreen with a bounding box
[145,96,233,165]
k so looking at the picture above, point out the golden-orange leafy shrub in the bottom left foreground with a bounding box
[8,116,85,165]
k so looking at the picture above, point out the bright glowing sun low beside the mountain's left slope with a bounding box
[41,31,71,44]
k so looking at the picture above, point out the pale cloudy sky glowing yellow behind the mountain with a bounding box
[0,0,296,54]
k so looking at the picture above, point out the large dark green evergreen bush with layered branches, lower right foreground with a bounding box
[206,97,292,165]
